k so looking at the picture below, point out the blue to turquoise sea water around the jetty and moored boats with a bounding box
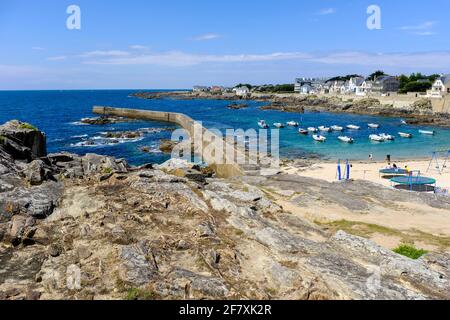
[0,90,450,165]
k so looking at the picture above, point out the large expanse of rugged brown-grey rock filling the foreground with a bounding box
[0,122,450,299]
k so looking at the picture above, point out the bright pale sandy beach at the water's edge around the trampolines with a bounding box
[283,159,450,189]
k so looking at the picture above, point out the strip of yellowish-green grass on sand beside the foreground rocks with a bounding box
[314,220,450,250]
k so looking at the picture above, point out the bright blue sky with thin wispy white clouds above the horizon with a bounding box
[0,0,450,90]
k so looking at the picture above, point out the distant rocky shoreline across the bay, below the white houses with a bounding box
[132,91,450,127]
